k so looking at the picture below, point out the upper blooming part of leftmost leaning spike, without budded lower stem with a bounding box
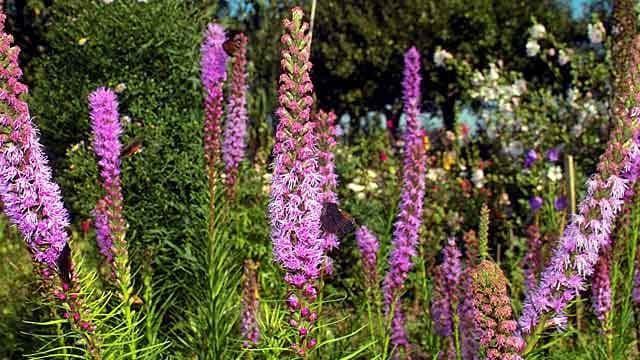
[0,13,69,269]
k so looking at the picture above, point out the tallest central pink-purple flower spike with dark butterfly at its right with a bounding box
[269,7,324,353]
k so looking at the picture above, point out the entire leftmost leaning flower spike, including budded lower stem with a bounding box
[0,11,99,358]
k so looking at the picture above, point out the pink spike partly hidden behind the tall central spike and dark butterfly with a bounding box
[315,110,340,259]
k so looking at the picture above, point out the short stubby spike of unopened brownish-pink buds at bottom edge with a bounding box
[470,260,524,360]
